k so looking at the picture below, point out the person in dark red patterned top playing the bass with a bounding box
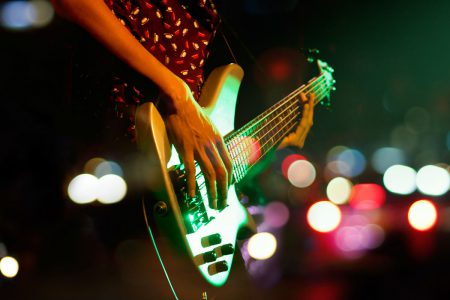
[52,0,323,298]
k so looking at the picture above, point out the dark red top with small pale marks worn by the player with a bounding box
[105,0,219,137]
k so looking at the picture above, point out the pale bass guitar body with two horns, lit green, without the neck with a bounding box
[136,64,255,287]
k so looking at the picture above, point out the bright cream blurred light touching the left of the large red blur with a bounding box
[306,201,342,232]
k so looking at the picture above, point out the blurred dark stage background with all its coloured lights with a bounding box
[0,0,450,300]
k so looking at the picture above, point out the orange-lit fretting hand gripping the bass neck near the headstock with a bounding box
[278,93,316,149]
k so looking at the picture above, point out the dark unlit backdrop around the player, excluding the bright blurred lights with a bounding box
[0,0,450,299]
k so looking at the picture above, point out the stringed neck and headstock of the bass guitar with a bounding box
[225,75,330,183]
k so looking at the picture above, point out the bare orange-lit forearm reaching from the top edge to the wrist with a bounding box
[52,0,176,93]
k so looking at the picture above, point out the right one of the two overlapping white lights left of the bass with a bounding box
[97,174,127,204]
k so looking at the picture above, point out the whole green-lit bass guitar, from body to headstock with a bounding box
[136,60,335,287]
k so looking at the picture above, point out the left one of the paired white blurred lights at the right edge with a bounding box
[383,165,416,195]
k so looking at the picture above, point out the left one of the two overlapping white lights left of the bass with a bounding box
[67,174,98,204]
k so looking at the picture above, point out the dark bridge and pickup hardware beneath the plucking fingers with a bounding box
[169,165,212,233]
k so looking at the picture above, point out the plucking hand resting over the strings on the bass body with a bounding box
[160,77,232,209]
